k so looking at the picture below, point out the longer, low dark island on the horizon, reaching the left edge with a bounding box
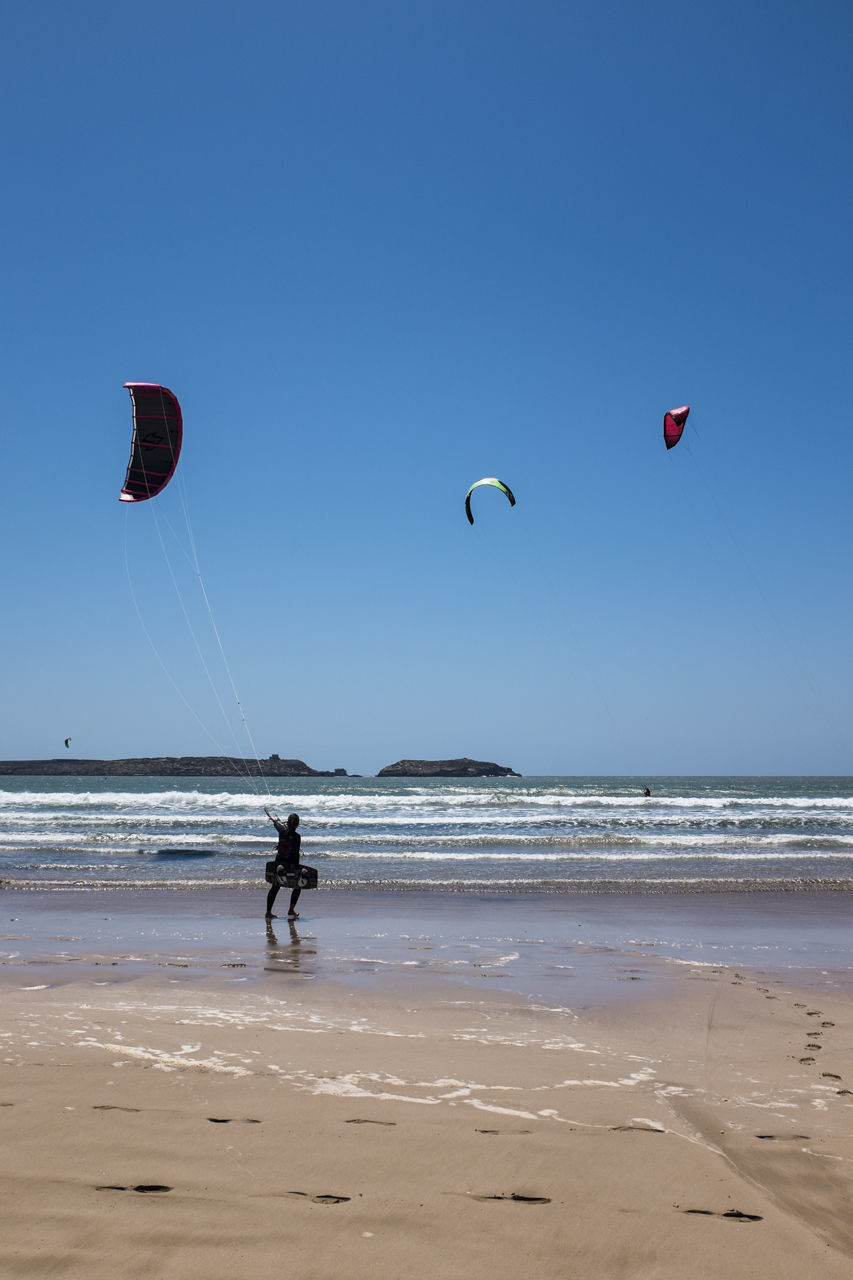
[0,755,347,778]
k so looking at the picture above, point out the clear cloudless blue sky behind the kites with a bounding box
[0,0,853,776]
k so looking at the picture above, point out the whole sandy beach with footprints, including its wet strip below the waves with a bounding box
[0,891,853,1280]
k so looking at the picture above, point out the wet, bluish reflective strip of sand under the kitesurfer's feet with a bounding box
[0,890,853,1007]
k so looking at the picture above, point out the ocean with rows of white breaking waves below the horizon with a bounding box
[0,776,853,893]
